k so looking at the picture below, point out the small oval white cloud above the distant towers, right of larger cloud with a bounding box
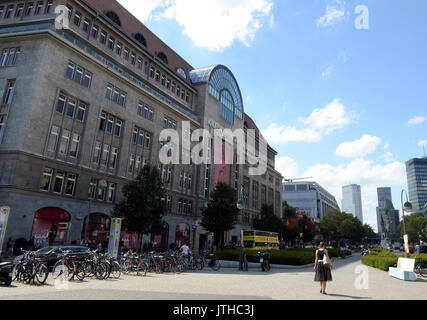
[335,134,382,158]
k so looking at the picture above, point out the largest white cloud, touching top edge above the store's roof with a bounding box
[119,0,274,51]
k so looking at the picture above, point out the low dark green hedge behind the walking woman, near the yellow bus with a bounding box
[216,248,351,266]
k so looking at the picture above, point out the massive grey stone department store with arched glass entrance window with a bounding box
[0,0,282,249]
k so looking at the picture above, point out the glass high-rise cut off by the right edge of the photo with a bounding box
[406,157,427,214]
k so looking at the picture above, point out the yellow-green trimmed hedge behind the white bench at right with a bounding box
[362,248,427,271]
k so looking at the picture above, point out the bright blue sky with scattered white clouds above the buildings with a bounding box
[119,0,427,229]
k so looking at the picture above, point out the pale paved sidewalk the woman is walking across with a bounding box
[0,255,427,300]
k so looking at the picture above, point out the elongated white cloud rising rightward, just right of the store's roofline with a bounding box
[262,99,357,144]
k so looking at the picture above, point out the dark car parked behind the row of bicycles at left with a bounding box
[14,246,90,270]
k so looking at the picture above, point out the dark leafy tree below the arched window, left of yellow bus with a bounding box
[201,182,239,248]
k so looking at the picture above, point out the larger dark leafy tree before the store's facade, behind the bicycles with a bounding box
[114,164,166,252]
